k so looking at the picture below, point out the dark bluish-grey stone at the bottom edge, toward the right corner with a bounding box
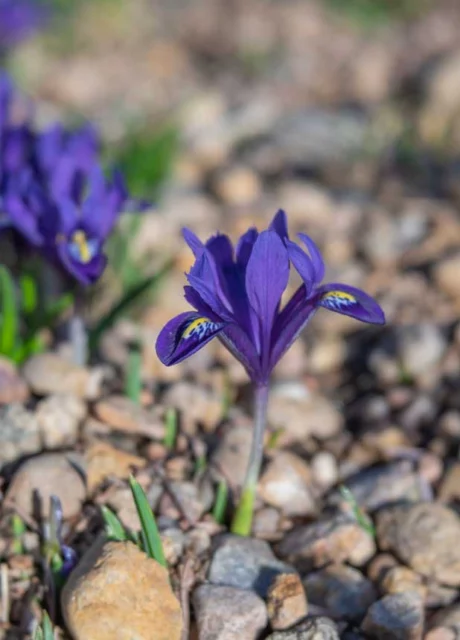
[362,591,424,640]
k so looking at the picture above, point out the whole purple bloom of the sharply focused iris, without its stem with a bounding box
[156,210,385,386]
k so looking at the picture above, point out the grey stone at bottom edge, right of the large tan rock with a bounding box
[193,584,267,640]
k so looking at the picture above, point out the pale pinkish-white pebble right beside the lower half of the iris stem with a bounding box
[259,451,316,516]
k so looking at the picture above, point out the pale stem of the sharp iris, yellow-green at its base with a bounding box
[231,384,269,536]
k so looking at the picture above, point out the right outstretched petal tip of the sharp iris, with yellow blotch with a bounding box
[314,283,385,324]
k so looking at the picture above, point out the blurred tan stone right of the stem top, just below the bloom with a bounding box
[268,386,343,446]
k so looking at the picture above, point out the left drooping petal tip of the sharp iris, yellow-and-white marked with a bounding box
[155,311,225,367]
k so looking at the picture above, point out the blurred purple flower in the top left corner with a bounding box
[0,0,47,50]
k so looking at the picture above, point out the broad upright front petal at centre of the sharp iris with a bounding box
[246,231,289,360]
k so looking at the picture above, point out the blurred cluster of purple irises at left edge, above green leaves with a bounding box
[0,75,141,285]
